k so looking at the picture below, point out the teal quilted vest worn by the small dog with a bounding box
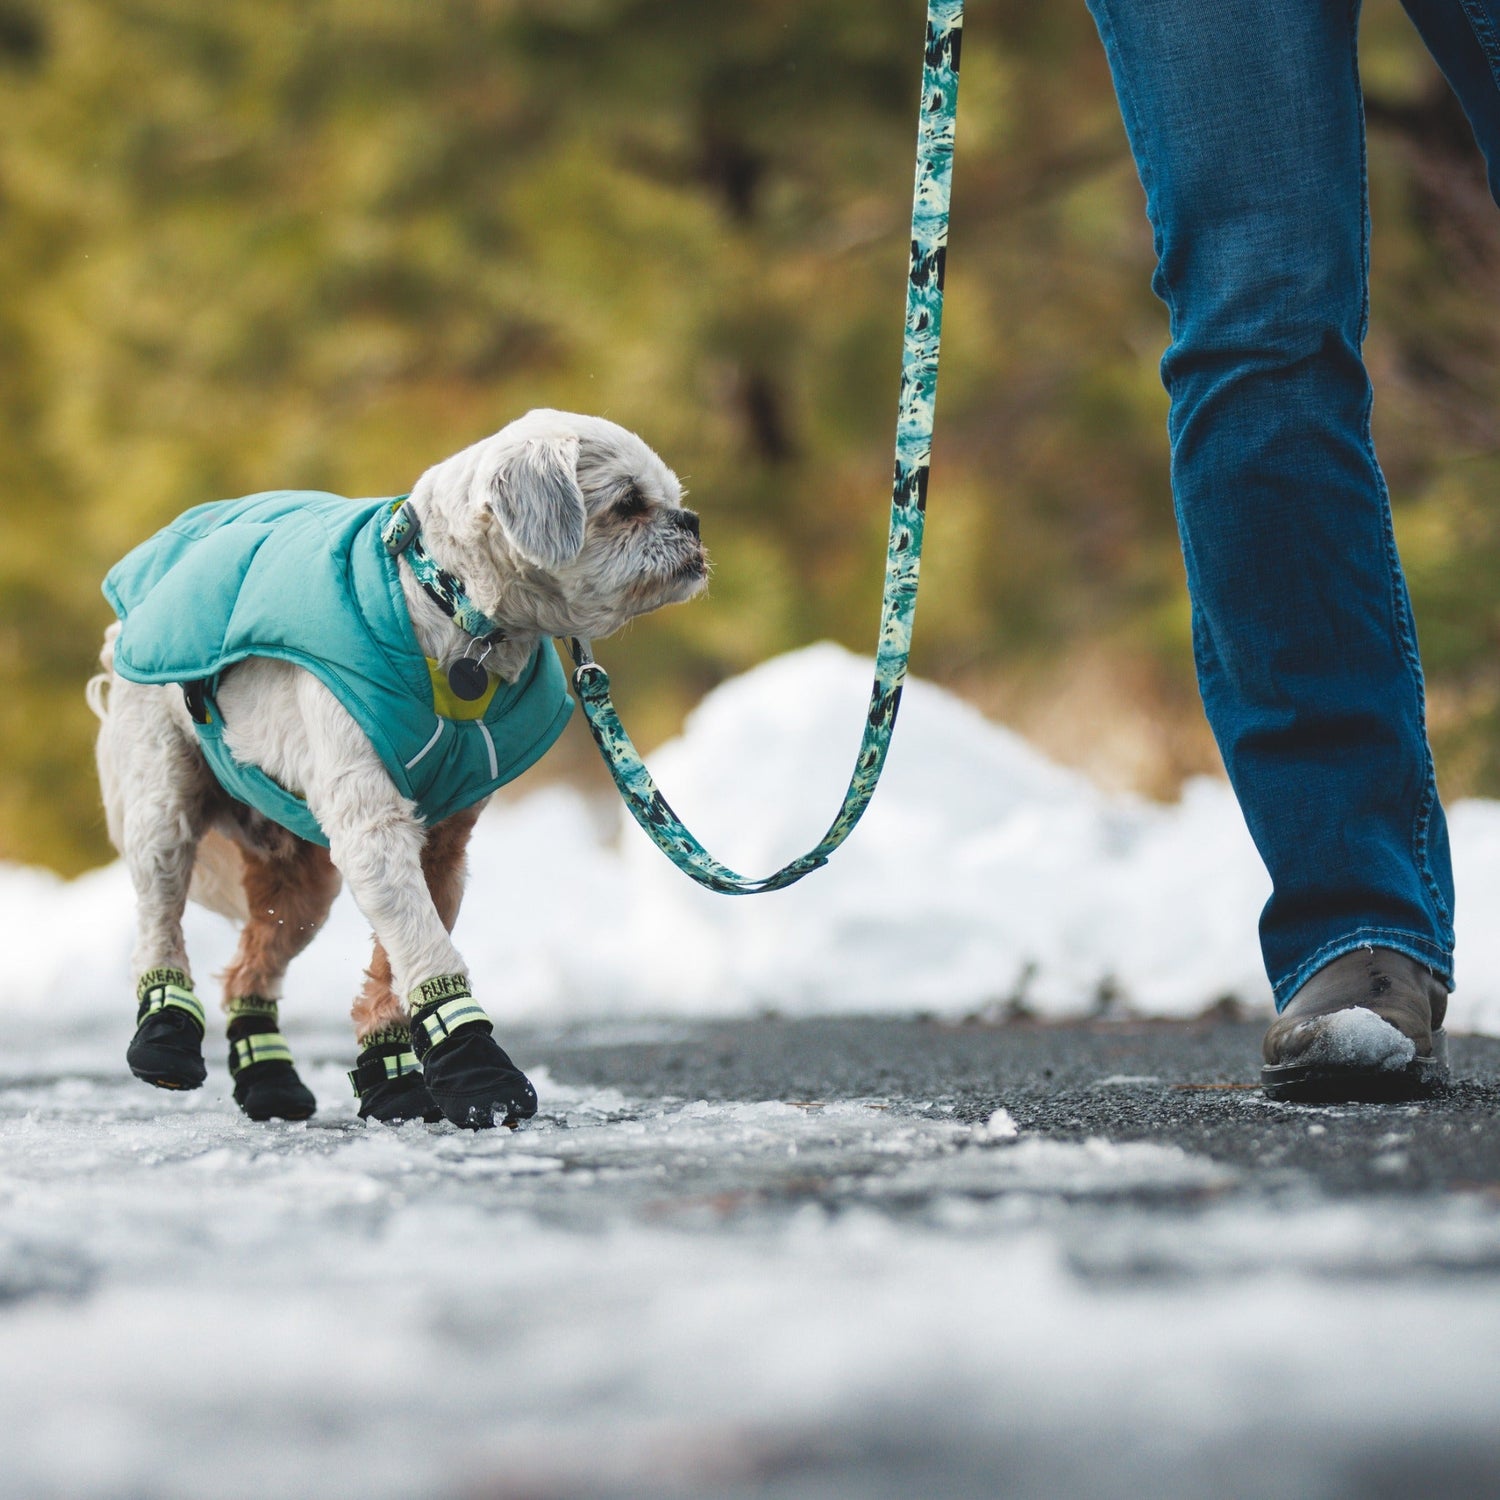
[104,491,573,846]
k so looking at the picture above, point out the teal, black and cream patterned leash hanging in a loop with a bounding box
[569,0,963,896]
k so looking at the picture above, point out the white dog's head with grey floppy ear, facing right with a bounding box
[407,411,708,675]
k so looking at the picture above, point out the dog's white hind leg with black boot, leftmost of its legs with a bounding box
[96,678,218,1089]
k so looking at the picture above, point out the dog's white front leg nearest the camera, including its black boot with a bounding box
[297,677,537,1130]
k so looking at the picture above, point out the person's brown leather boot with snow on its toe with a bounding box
[1260,948,1448,1103]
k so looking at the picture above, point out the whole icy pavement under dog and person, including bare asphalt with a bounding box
[0,1016,1500,1500]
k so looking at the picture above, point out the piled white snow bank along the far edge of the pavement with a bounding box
[0,645,1500,1032]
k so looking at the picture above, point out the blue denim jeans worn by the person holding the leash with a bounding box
[1088,0,1500,1010]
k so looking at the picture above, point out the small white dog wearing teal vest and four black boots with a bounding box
[89,411,708,1128]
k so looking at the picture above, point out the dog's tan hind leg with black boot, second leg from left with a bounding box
[224,834,339,1121]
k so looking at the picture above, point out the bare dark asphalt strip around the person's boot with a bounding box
[522,1017,1500,1202]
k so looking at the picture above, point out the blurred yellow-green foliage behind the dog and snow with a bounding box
[0,0,1500,870]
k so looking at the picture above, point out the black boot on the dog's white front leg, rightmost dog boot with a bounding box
[411,974,537,1130]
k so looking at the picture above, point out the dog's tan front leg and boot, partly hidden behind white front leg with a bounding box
[351,803,485,1124]
